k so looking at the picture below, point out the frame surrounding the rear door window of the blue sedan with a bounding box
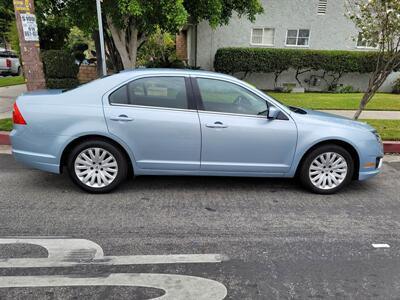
[106,74,197,111]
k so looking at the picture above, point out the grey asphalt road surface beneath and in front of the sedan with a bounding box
[0,154,400,300]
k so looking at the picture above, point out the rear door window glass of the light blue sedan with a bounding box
[110,77,188,109]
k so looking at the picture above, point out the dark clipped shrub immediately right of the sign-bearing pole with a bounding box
[42,50,79,89]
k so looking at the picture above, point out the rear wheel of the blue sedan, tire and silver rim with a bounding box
[67,140,128,194]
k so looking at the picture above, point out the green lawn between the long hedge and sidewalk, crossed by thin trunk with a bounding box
[267,92,400,110]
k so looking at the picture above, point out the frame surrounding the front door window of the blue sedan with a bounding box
[191,76,272,119]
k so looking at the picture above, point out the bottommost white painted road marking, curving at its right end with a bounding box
[0,273,227,300]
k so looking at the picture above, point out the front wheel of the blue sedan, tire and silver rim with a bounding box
[299,144,354,195]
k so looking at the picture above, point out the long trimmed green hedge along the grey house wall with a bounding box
[214,48,377,89]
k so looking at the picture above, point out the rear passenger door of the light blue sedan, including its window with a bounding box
[104,76,201,170]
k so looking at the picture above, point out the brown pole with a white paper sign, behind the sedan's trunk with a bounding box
[13,0,46,91]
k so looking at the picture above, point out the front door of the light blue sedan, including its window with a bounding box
[192,77,297,174]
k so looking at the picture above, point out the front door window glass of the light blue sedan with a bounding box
[197,78,268,115]
